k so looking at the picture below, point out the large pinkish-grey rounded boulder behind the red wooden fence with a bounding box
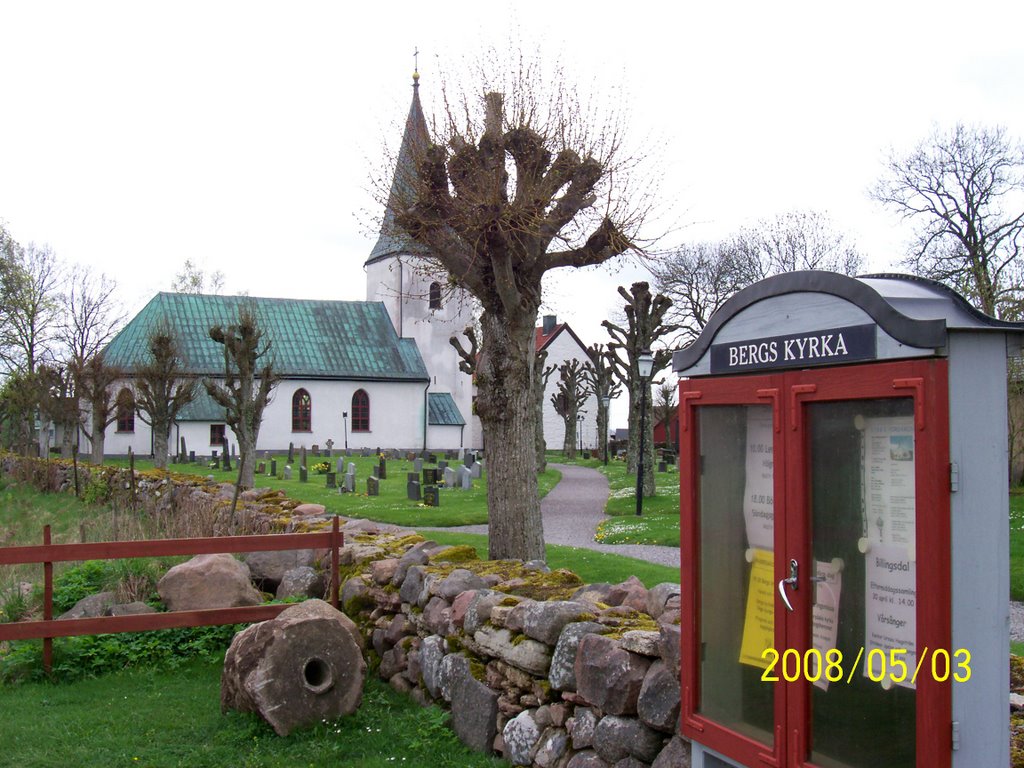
[157,555,263,610]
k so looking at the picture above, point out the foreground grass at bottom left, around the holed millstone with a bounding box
[0,660,507,768]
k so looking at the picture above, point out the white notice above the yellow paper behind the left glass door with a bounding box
[743,408,775,552]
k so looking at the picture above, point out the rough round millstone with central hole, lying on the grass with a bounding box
[220,600,367,736]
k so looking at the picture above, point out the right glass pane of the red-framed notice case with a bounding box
[804,398,916,768]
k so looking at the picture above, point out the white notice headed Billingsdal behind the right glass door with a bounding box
[864,546,918,688]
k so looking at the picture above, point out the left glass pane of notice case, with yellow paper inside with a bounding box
[696,406,775,751]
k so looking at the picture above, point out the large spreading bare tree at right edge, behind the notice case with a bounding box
[871,123,1024,318]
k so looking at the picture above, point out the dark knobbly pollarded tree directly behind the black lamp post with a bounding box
[601,283,677,496]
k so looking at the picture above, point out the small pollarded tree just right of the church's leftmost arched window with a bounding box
[134,322,197,469]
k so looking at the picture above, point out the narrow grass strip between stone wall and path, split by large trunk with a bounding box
[422,530,679,588]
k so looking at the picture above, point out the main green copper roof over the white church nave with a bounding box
[106,293,429,381]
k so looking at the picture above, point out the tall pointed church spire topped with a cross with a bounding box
[365,60,430,265]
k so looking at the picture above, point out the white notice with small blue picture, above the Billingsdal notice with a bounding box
[864,416,915,558]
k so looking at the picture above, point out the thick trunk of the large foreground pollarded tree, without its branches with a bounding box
[476,307,545,560]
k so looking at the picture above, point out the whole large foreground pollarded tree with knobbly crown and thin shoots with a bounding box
[385,54,650,559]
